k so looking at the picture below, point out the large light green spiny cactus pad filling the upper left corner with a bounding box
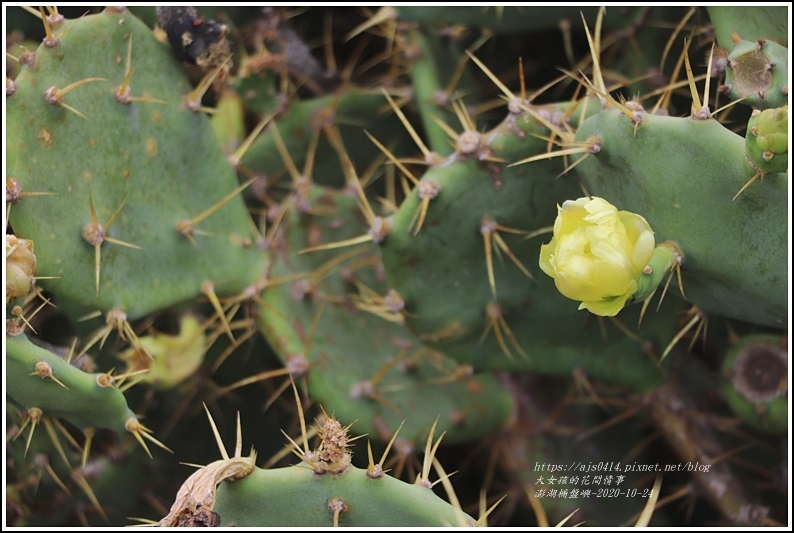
[6,10,265,319]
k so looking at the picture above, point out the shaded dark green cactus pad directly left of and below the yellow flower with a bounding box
[382,103,674,388]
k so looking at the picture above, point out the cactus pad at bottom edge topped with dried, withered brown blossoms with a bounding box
[159,406,475,527]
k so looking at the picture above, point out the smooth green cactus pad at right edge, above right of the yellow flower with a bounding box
[576,109,789,327]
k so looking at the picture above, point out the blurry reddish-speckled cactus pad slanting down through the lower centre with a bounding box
[258,186,512,443]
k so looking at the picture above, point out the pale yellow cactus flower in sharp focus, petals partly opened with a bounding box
[540,197,655,316]
